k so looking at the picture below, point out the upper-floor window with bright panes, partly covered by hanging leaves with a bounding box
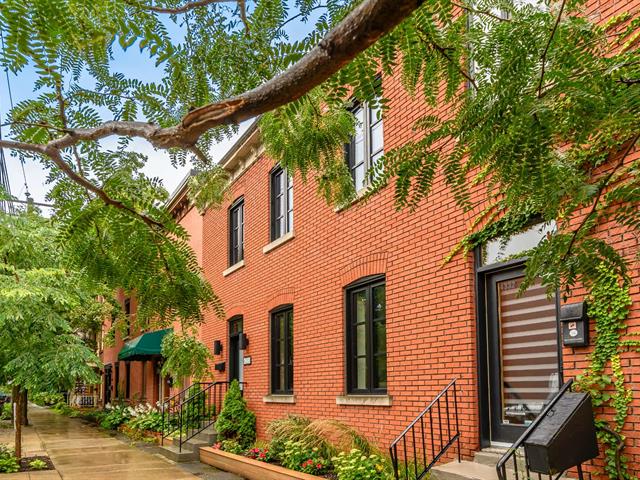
[347,103,384,191]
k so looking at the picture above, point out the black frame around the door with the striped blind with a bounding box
[474,255,564,448]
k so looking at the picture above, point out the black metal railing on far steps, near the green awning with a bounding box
[162,381,244,452]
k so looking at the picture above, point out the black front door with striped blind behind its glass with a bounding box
[484,267,561,443]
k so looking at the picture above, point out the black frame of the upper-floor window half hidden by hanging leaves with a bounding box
[345,100,384,191]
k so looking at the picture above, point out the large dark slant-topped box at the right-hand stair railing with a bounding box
[524,392,598,475]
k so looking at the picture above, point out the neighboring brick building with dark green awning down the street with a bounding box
[99,172,202,405]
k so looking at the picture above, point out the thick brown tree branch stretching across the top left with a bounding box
[0,0,424,221]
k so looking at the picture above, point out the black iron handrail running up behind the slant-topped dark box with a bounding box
[496,380,584,480]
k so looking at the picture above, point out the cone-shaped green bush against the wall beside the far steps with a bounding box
[216,380,256,450]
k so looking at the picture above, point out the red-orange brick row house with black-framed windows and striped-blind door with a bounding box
[97,1,640,471]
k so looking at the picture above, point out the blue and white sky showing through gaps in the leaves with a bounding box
[0,1,308,213]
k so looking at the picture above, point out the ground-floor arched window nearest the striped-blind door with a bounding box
[346,276,387,394]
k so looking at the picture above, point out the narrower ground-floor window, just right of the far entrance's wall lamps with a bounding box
[271,305,293,395]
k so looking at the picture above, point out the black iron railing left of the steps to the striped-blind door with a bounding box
[389,378,460,480]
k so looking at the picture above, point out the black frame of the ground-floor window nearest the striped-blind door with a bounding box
[345,275,388,395]
